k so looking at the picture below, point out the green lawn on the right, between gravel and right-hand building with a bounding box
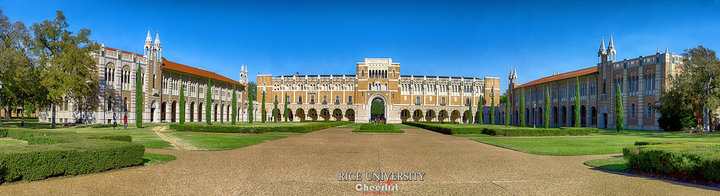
[472,134,720,156]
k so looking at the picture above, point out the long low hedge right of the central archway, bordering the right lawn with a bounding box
[403,121,598,136]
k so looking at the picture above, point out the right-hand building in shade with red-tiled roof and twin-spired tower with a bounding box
[508,36,683,130]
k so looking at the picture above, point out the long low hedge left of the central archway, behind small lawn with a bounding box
[170,121,352,133]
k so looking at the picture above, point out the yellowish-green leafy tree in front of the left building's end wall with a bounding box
[31,11,100,128]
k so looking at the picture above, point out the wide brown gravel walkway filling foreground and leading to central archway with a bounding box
[0,128,720,195]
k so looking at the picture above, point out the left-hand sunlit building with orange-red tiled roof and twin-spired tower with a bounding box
[39,31,248,123]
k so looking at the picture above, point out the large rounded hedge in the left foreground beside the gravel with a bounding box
[0,129,145,182]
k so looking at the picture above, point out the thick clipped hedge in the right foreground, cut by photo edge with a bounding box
[623,141,720,183]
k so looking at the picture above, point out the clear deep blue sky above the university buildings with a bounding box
[0,0,720,90]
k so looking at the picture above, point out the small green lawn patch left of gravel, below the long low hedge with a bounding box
[164,131,287,150]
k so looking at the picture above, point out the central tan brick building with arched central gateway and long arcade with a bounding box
[254,58,503,123]
